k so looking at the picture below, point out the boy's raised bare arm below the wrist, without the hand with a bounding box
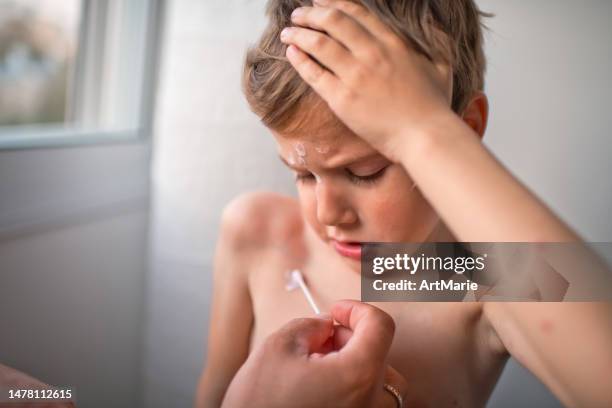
[405,120,612,407]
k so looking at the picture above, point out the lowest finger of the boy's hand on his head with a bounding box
[286,45,342,102]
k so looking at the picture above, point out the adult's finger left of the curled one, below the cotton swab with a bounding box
[267,316,333,356]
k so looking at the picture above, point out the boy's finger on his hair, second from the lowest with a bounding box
[281,27,355,77]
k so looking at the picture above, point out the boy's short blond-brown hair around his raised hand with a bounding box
[242,0,489,132]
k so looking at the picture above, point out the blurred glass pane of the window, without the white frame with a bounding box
[0,0,81,126]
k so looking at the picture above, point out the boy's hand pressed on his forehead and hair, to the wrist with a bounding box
[281,0,452,161]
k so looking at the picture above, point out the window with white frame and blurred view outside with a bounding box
[0,0,159,148]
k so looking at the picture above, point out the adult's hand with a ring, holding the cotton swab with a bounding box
[223,301,406,408]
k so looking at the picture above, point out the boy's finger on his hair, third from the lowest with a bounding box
[291,7,376,55]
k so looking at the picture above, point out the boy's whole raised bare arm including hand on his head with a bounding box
[281,1,612,407]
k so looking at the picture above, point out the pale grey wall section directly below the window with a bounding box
[0,142,149,408]
